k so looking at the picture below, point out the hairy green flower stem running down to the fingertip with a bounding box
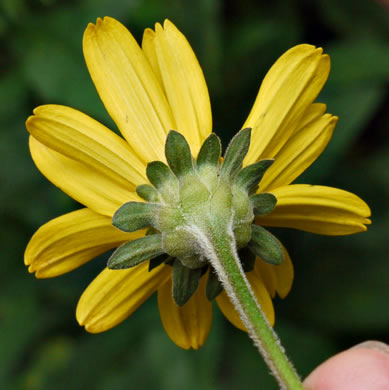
[198,224,303,390]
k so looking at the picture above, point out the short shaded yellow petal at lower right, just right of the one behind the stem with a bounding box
[253,243,294,298]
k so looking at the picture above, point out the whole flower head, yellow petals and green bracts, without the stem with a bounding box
[25,17,370,349]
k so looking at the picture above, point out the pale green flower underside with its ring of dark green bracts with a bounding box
[108,128,284,306]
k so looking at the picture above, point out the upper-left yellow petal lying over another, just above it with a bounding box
[26,105,147,191]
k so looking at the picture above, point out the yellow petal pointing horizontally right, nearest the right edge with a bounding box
[256,184,370,235]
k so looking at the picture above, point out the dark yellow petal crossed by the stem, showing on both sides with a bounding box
[216,272,275,332]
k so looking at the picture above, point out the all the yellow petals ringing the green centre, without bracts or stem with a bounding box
[25,17,370,349]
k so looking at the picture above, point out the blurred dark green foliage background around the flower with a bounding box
[0,0,389,390]
